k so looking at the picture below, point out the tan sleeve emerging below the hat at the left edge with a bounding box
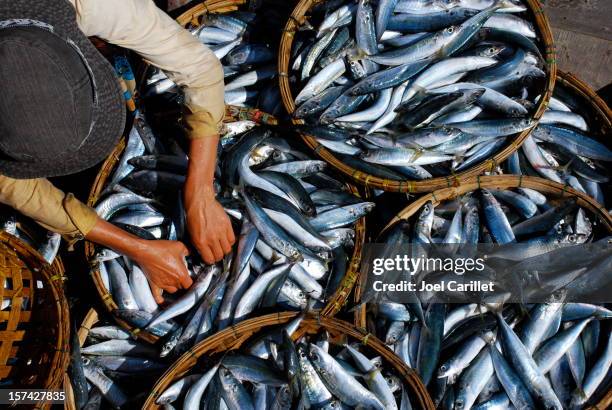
[0,175,98,241]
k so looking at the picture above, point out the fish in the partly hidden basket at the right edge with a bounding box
[498,86,612,206]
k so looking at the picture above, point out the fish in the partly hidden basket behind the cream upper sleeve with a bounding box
[143,11,282,115]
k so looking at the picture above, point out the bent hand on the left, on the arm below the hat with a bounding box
[130,240,193,304]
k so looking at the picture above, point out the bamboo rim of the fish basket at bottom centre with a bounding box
[143,312,434,410]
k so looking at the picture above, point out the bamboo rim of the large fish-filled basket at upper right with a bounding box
[278,0,557,193]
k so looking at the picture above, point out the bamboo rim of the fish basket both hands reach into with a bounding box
[85,106,366,343]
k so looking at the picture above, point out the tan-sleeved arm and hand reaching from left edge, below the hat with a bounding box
[0,175,191,302]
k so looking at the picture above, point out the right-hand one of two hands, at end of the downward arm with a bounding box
[185,187,236,265]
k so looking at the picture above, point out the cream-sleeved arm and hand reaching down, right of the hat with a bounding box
[75,0,235,264]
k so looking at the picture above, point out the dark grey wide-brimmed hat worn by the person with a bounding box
[0,0,125,178]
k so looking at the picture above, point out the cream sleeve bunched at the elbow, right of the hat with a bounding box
[73,0,225,138]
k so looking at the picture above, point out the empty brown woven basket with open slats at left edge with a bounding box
[0,232,70,408]
